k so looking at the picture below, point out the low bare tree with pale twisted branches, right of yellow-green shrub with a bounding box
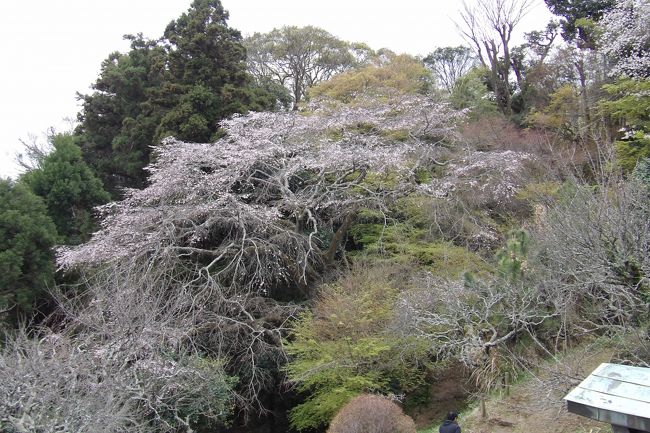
[396,274,557,368]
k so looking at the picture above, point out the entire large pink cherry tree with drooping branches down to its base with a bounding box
[52,96,464,411]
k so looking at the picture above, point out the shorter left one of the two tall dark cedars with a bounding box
[76,34,166,195]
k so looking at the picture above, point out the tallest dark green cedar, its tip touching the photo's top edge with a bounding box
[156,0,276,142]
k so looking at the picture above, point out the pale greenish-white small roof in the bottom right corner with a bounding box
[564,363,650,432]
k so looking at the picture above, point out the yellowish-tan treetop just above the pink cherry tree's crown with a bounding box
[309,54,431,103]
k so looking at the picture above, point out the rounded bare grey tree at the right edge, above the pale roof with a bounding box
[533,181,650,335]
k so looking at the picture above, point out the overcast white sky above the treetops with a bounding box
[0,0,550,177]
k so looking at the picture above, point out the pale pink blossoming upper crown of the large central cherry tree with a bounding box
[59,96,463,284]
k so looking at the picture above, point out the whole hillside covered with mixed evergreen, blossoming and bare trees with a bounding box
[0,0,650,433]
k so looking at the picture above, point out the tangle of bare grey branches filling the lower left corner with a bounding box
[0,266,233,433]
